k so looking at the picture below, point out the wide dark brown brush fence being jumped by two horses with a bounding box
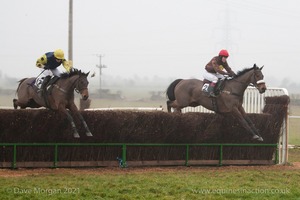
[0,89,289,168]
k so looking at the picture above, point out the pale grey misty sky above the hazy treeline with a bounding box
[0,0,300,86]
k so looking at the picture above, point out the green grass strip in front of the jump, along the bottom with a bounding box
[0,167,300,199]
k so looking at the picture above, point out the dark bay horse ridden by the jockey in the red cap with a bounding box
[167,64,267,141]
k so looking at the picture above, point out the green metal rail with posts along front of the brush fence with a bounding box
[0,143,279,169]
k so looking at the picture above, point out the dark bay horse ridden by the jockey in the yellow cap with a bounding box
[13,69,93,138]
